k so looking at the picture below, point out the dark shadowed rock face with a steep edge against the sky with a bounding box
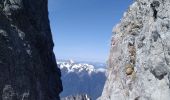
[0,0,62,100]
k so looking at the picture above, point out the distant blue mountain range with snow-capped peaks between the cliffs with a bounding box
[58,60,106,100]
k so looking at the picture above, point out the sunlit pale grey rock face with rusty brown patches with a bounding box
[100,0,170,100]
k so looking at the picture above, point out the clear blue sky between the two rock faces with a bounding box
[48,0,133,62]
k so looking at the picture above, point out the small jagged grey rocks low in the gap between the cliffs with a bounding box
[61,95,91,100]
